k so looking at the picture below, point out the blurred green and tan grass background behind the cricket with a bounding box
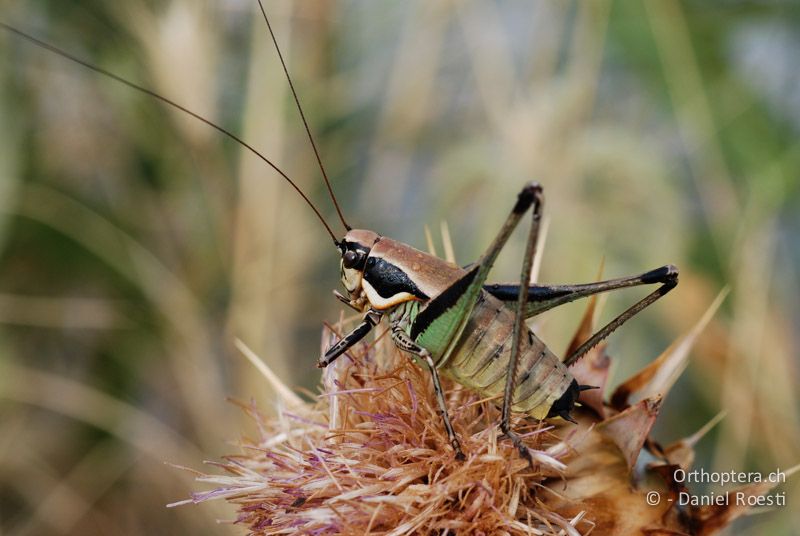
[0,0,800,535]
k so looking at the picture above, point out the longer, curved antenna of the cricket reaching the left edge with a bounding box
[0,21,339,245]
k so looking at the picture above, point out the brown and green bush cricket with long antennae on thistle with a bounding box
[0,0,678,463]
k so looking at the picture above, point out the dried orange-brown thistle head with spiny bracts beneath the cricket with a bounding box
[176,297,788,535]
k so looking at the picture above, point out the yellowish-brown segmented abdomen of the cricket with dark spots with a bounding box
[437,291,573,419]
